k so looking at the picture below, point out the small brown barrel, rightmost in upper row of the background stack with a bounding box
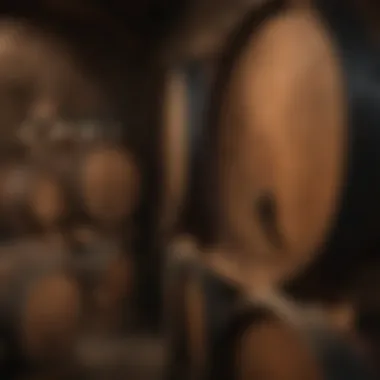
[40,144,140,227]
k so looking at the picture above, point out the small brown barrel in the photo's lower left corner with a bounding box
[0,241,81,373]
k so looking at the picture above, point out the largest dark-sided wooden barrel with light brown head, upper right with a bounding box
[165,1,379,306]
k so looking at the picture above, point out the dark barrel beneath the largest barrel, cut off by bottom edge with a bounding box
[165,242,376,380]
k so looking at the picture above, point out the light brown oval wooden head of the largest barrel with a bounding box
[211,2,347,287]
